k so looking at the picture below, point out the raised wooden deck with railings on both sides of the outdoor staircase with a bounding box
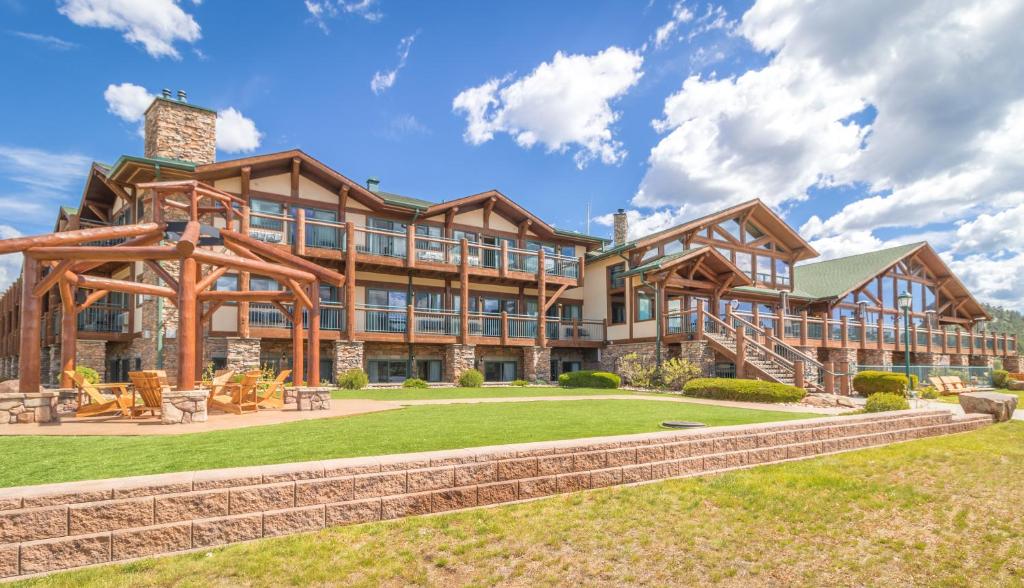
[663,310,1018,356]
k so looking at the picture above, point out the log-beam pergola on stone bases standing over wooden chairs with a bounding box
[0,180,345,393]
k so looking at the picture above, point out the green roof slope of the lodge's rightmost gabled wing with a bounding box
[793,243,925,299]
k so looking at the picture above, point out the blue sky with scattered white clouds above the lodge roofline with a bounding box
[0,0,1024,306]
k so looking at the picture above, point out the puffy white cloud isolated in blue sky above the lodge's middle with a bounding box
[452,47,643,168]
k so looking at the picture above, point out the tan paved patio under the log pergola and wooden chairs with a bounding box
[0,400,401,436]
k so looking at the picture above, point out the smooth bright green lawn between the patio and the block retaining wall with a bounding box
[0,400,806,487]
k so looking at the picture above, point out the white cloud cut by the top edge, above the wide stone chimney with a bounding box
[57,0,202,59]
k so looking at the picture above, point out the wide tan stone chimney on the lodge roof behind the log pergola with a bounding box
[144,89,217,164]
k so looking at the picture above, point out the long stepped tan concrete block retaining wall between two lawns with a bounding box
[0,411,991,578]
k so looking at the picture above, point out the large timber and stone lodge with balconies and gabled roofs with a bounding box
[0,95,1020,385]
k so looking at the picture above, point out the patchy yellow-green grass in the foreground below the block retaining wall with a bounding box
[14,422,1024,587]
